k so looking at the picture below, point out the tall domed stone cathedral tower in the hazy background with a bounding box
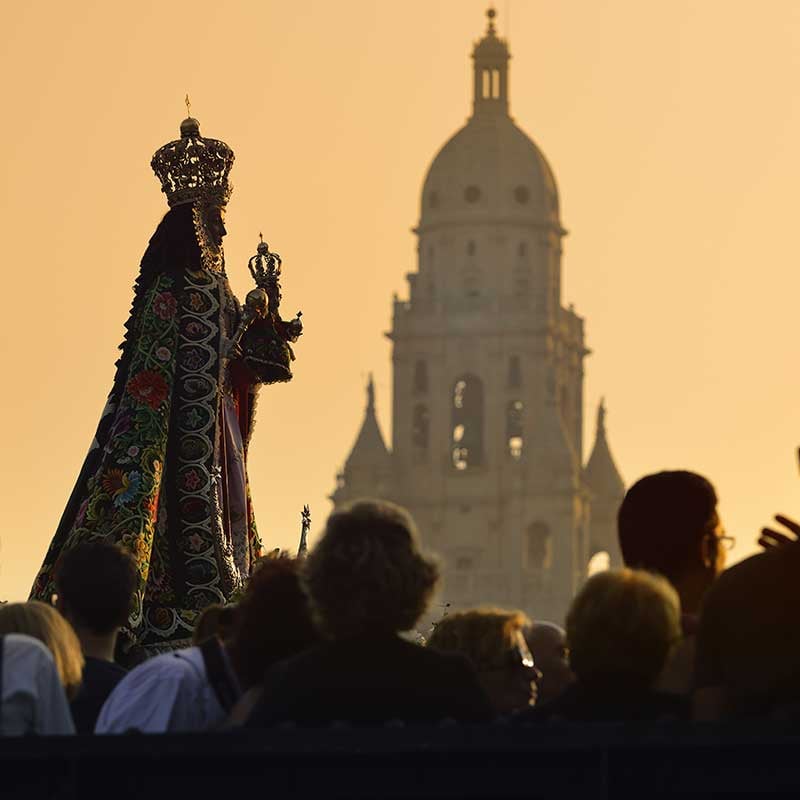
[333,10,622,620]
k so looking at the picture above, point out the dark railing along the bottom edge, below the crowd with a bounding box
[0,723,800,800]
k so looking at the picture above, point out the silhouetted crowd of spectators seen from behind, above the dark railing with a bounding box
[0,471,800,735]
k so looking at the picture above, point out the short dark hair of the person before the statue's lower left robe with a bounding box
[55,540,138,634]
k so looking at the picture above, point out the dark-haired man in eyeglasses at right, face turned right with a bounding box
[617,470,735,695]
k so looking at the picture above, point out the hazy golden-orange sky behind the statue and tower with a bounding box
[0,0,800,600]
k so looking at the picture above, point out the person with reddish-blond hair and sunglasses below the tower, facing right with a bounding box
[428,608,542,714]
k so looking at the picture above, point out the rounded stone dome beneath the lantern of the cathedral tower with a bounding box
[420,113,561,231]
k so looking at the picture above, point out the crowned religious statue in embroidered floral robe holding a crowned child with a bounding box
[31,101,302,655]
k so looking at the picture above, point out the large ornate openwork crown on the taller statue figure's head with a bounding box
[150,109,234,208]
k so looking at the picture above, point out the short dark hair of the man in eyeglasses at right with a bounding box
[617,470,718,581]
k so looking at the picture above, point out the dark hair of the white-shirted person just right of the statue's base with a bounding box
[222,558,319,689]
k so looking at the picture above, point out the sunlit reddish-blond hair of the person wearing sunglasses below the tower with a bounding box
[428,608,530,672]
